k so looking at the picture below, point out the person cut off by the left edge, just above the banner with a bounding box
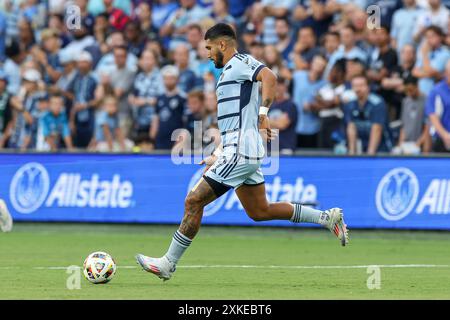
[0,69,14,149]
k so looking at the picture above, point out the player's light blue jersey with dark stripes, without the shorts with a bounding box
[216,53,264,158]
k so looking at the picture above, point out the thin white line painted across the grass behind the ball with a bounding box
[11,264,450,270]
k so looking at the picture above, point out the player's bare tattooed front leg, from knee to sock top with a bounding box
[178,178,217,239]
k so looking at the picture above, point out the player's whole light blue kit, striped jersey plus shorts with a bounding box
[205,53,265,190]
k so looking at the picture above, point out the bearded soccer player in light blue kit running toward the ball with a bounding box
[136,23,348,280]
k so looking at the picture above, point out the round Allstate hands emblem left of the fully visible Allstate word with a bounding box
[9,162,50,213]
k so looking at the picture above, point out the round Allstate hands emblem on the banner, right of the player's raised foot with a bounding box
[376,168,419,221]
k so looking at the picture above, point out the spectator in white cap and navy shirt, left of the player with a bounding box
[150,65,186,150]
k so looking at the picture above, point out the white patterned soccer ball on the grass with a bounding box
[83,251,117,283]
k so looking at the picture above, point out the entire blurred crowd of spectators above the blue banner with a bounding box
[0,0,450,154]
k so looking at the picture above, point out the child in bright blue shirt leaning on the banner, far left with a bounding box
[39,94,73,151]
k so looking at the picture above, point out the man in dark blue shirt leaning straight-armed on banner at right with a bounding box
[344,76,390,155]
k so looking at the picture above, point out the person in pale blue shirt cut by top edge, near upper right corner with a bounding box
[391,0,422,54]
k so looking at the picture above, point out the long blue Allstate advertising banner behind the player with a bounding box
[0,154,450,230]
